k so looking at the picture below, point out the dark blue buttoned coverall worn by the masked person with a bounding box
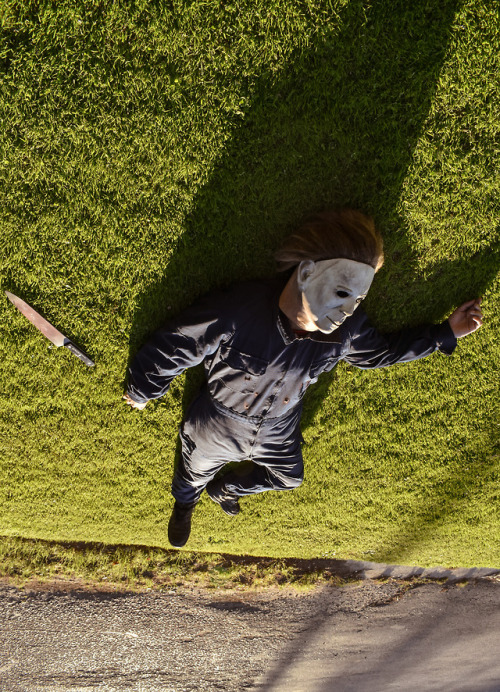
[128,275,456,503]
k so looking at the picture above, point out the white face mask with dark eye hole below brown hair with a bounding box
[297,259,375,334]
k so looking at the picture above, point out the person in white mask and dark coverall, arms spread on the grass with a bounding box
[124,210,482,547]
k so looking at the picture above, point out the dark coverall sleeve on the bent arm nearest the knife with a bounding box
[127,291,233,403]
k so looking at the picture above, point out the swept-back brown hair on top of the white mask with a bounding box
[274,209,384,271]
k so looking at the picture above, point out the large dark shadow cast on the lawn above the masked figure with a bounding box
[130,0,499,559]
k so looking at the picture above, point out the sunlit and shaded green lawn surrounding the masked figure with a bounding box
[0,0,500,566]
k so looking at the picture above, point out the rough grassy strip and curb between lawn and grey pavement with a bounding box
[0,537,500,592]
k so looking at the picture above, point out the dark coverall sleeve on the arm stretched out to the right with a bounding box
[343,315,457,368]
